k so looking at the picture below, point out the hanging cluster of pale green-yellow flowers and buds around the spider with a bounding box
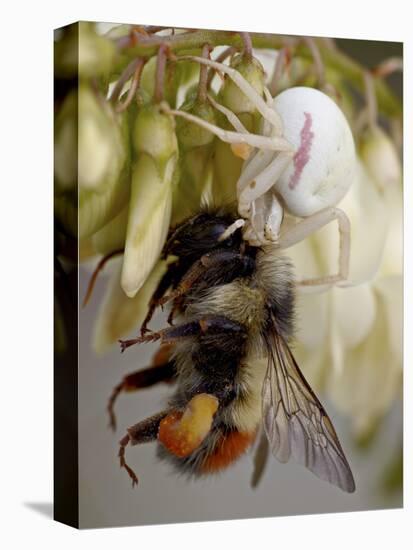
[55,23,402,462]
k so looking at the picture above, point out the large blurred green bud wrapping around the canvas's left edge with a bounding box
[55,84,130,238]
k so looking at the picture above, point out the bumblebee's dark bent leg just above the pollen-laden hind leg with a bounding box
[107,361,175,430]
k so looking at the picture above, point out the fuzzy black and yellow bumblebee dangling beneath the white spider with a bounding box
[112,212,355,492]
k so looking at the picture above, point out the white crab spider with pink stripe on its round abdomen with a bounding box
[163,56,356,286]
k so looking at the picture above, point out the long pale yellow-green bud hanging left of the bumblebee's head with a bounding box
[121,105,178,298]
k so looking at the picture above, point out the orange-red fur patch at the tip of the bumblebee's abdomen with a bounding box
[201,431,256,474]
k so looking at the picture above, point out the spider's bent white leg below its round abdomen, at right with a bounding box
[278,208,351,287]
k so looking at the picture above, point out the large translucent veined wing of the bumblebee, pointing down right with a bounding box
[262,331,355,493]
